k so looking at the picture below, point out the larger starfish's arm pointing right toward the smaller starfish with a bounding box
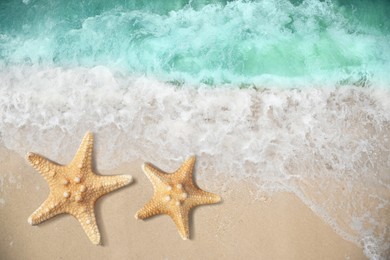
[94,175,133,198]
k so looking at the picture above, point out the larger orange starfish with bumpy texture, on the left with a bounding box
[27,132,132,245]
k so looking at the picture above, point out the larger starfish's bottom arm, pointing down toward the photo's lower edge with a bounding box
[72,205,100,245]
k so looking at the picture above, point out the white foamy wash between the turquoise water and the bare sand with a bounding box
[0,66,390,259]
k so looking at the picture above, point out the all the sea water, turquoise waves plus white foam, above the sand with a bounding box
[0,0,390,259]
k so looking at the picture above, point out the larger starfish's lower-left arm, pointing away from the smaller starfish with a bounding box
[27,196,64,225]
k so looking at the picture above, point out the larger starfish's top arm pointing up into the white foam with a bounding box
[70,131,93,171]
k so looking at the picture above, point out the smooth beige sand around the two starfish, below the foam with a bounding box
[0,148,366,260]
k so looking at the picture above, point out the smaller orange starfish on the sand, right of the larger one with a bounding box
[135,156,221,240]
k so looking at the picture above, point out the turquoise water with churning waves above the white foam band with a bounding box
[0,0,390,86]
